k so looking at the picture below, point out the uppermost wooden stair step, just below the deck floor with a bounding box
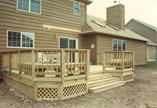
[89,73,112,81]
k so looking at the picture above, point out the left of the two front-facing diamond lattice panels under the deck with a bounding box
[37,88,58,99]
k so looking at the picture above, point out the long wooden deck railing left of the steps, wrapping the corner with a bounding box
[2,49,90,80]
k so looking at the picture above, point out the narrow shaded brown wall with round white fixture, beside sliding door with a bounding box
[85,35,97,64]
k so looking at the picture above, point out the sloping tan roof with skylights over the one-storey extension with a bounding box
[80,15,150,41]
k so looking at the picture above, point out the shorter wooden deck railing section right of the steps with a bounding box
[97,51,134,71]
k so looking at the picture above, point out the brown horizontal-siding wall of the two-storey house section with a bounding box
[0,0,86,51]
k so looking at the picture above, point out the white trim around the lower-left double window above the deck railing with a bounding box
[6,30,35,49]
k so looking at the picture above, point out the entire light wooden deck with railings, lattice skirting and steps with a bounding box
[2,49,134,101]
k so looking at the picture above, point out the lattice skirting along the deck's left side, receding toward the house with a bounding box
[4,77,34,99]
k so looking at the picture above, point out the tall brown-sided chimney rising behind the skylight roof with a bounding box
[106,4,125,30]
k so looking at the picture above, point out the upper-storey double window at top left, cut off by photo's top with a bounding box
[18,0,41,14]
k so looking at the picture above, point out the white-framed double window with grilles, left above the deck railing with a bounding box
[8,31,34,48]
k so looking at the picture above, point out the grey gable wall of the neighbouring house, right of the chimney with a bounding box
[126,20,157,43]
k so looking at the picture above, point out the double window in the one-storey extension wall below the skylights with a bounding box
[113,39,126,51]
